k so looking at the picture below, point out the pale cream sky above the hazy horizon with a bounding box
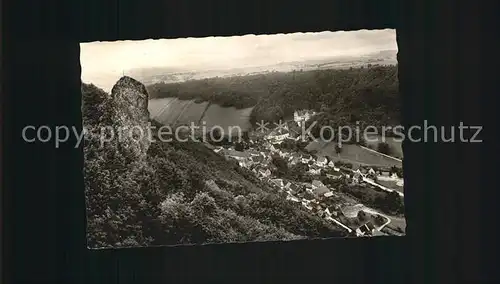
[80,29,397,90]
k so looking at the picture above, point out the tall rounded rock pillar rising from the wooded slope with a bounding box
[111,76,151,158]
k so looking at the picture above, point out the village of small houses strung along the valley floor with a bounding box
[205,111,406,237]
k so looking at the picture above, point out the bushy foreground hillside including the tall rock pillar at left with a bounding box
[82,77,344,248]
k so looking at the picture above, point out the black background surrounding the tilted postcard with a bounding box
[2,0,495,284]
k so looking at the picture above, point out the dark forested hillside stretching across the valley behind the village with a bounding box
[148,65,400,126]
